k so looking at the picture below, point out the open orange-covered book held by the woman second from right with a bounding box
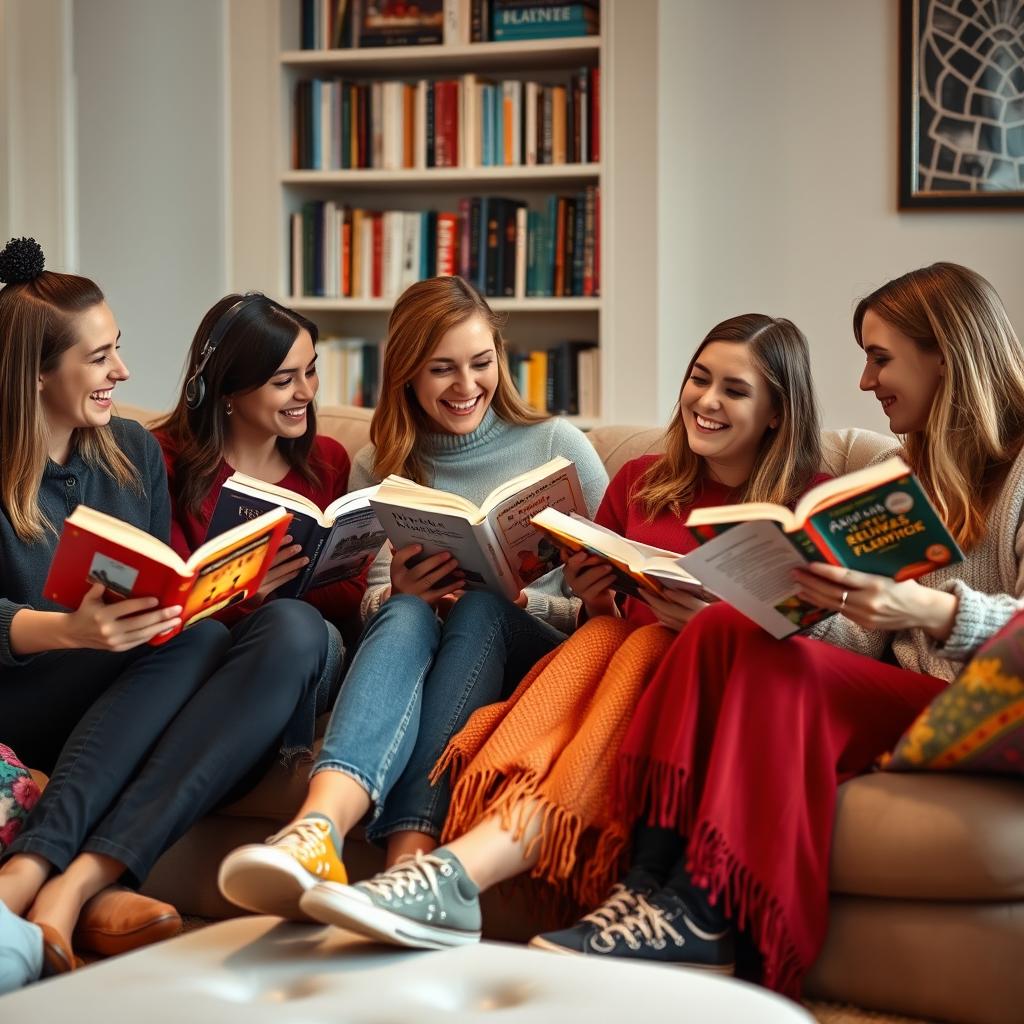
[532,508,715,601]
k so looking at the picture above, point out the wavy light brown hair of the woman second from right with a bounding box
[630,313,821,519]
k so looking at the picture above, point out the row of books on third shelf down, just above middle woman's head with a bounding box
[291,185,601,299]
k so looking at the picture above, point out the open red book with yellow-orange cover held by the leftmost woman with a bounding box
[43,505,291,645]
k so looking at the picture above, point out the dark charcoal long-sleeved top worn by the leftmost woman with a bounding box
[0,417,171,668]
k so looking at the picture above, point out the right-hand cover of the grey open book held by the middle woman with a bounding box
[487,459,587,593]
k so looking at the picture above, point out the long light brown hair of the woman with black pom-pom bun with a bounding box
[0,270,141,543]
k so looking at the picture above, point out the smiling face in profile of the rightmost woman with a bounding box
[860,309,945,434]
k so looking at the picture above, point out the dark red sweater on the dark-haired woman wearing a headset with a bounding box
[156,431,366,625]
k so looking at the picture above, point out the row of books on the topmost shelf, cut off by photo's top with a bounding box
[299,0,600,50]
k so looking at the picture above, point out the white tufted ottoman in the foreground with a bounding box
[0,918,812,1024]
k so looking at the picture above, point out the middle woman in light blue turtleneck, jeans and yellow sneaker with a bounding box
[219,278,608,919]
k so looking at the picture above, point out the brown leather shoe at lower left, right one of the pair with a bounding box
[74,886,181,956]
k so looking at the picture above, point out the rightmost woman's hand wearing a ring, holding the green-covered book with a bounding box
[794,562,958,640]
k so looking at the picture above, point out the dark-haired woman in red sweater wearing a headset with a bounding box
[154,293,366,755]
